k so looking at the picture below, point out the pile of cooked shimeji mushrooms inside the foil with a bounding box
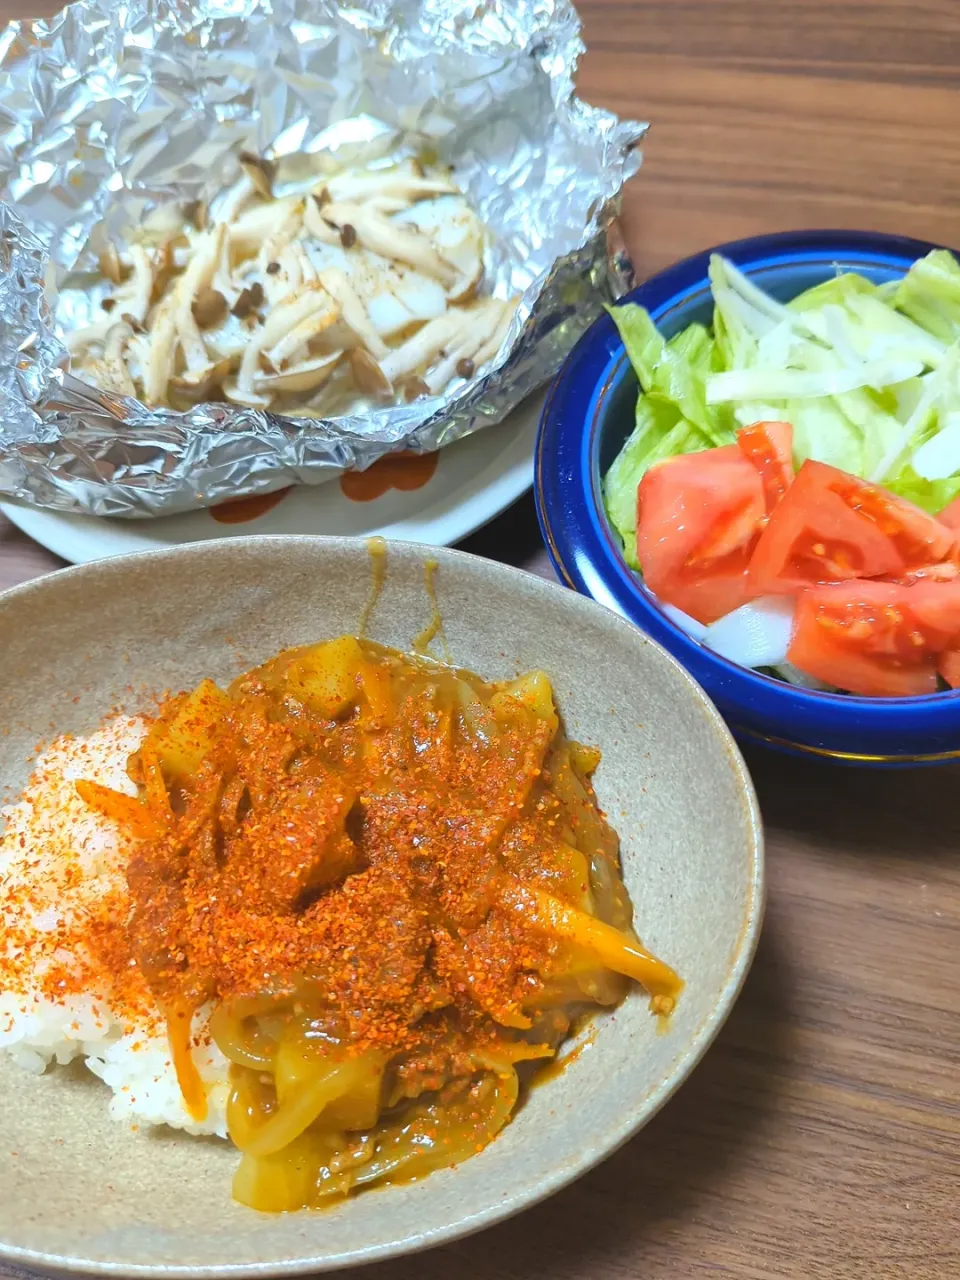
[68,146,515,411]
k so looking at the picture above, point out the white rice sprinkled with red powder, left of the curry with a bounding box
[0,716,228,1137]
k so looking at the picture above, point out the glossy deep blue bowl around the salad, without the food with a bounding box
[535,232,960,765]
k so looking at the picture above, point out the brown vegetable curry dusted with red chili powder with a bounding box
[78,636,681,1211]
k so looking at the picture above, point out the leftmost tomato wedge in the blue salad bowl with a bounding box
[636,444,767,622]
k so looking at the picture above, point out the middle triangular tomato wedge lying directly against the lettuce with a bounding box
[748,461,956,595]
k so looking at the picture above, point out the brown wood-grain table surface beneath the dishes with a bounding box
[0,0,960,1280]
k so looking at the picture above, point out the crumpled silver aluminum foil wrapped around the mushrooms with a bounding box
[0,0,646,517]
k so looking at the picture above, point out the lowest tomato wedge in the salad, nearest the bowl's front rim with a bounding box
[787,581,960,698]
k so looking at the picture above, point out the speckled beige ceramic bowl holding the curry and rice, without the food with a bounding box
[0,538,763,1277]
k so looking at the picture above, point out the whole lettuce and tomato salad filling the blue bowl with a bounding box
[603,250,960,696]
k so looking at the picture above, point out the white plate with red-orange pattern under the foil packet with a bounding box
[0,396,543,564]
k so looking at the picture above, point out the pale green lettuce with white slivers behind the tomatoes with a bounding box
[603,250,960,568]
